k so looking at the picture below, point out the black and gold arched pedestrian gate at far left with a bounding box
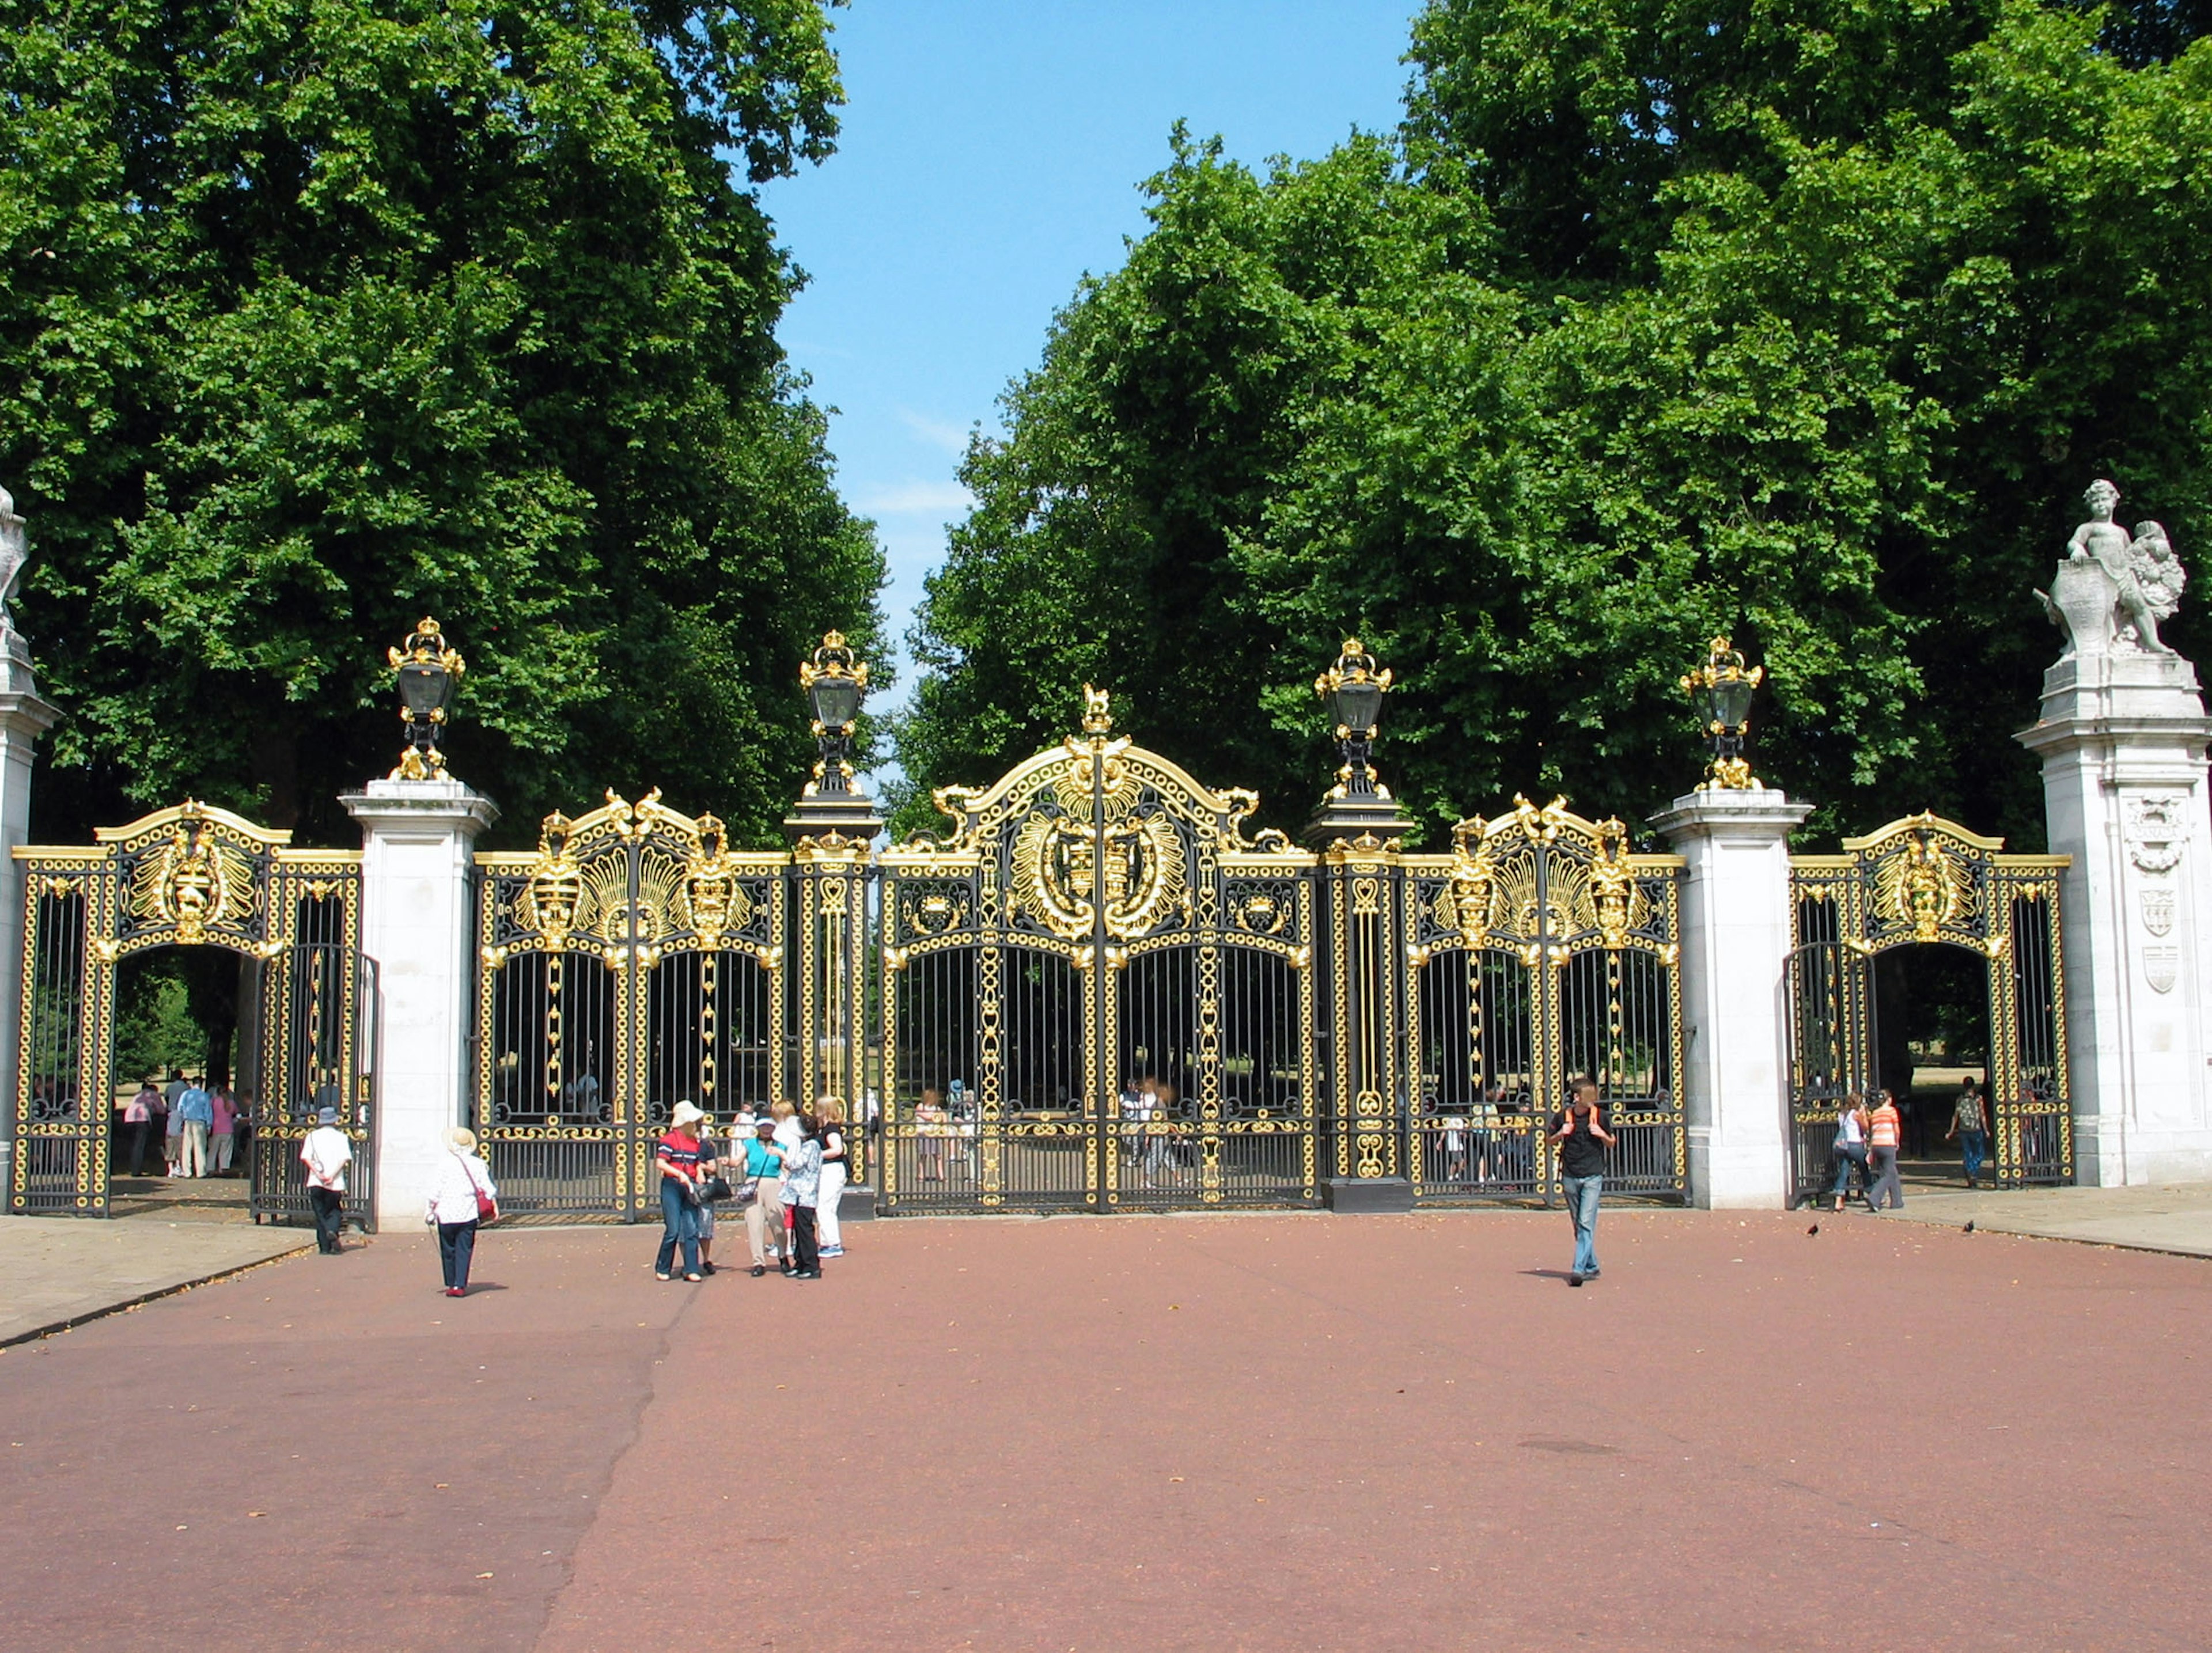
[9,801,378,1226]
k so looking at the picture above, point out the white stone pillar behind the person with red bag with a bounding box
[339,779,500,1228]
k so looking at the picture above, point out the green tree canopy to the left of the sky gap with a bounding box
[0,0,882,841]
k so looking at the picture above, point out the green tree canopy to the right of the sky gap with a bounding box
[900,0,2212,847]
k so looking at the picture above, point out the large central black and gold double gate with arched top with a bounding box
[876,693,1320,1212]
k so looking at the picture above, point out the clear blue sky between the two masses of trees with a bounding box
[763,0,1418,703]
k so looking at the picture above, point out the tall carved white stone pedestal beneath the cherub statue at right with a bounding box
[2017,653,2212,1186]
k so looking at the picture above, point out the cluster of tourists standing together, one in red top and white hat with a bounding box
[653,1095,850,1282]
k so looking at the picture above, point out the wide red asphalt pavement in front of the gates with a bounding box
[0,1211,2212,1653]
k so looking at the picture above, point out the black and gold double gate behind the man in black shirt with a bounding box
[1404,799,1688,1201]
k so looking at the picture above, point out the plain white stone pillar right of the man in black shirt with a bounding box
[1652,788,1812,1211]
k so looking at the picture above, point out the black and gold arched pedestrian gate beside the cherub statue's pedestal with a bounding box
[1785,812,2073,1199]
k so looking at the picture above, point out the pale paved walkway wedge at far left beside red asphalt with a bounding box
[0,1217,314,1345]
